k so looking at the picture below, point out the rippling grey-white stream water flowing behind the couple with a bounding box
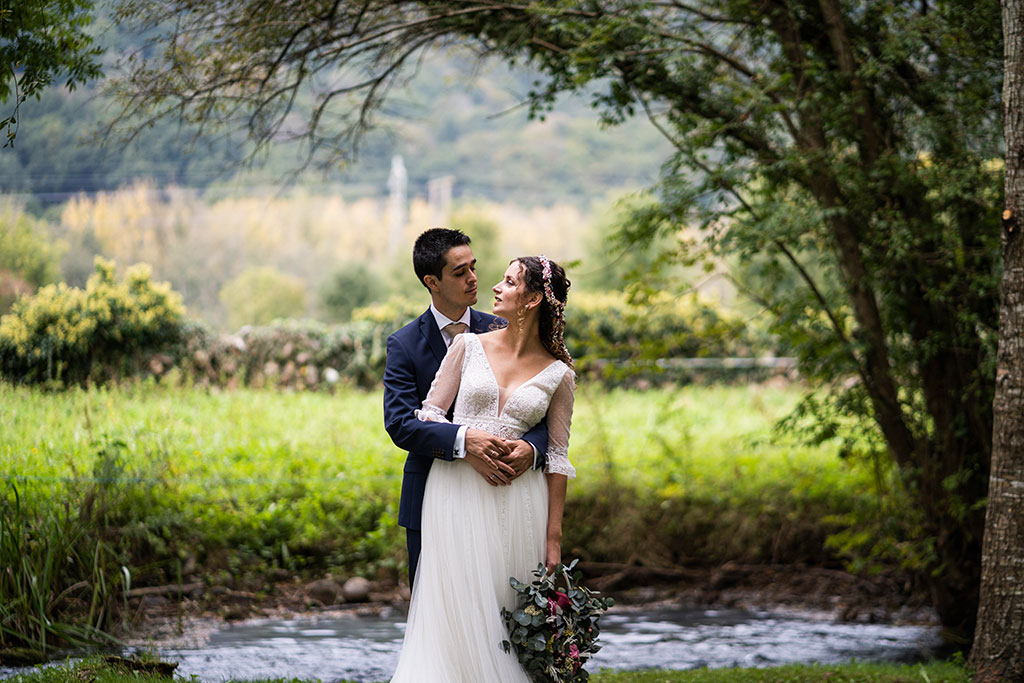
[103,609,941,683]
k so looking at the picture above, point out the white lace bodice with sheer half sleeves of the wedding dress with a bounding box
[416,332,575,477]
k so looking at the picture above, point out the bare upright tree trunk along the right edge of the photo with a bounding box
[971,0,1024,682]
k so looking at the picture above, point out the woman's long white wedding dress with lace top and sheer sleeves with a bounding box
[391,333,575,683]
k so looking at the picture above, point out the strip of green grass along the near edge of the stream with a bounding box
[0,657,971,683]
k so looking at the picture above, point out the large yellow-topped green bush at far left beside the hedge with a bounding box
[0,258,184,384]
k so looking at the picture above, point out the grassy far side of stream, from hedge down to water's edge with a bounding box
[0,383,930,658]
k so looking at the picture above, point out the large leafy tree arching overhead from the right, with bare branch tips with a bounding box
[110,0,1001,639]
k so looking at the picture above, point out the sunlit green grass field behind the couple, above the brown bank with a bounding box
[0,384,877,584]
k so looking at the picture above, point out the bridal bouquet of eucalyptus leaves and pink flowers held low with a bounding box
[502,560,614,683]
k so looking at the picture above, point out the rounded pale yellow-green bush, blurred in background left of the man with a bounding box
[219,266,306,329]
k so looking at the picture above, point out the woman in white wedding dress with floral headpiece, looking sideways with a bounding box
[391,256,575,683]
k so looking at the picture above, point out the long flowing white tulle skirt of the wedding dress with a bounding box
[391,461,548,683]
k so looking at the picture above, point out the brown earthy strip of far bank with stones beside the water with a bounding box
[120,562,938,650]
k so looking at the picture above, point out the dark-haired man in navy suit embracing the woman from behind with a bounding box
[384,227,548,588]
